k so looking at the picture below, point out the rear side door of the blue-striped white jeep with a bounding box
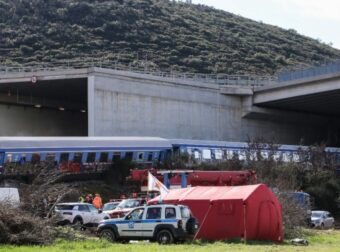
[142,207,162,237]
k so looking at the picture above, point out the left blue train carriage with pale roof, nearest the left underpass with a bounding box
[0,137,172,173]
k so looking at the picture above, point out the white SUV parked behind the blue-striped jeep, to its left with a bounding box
[54,202,110,226]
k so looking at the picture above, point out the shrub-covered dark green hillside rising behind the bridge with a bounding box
[0,0,340,74]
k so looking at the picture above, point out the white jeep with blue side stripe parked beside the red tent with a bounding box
[97,204,198,244]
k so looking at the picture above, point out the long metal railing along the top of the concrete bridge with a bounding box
[0,61,277,87]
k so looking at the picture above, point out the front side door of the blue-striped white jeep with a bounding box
[119,208,144,237]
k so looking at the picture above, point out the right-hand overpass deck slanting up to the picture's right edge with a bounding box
[253,72,340,116]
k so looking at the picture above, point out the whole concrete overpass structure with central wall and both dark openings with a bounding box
[0,61,340,146]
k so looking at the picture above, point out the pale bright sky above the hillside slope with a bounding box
[192,0,340,49]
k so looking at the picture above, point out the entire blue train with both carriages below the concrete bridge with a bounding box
[0,137,340,173]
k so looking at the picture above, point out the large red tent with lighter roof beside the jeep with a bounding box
[149,184,283,242]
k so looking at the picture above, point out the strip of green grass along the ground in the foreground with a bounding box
[0,230,340,252]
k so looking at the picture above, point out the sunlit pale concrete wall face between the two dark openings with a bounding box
[94,74,236,139]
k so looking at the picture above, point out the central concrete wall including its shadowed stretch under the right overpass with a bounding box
[89,71,330,144]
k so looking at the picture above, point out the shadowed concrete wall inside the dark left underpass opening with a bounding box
[0,105,87,136]
